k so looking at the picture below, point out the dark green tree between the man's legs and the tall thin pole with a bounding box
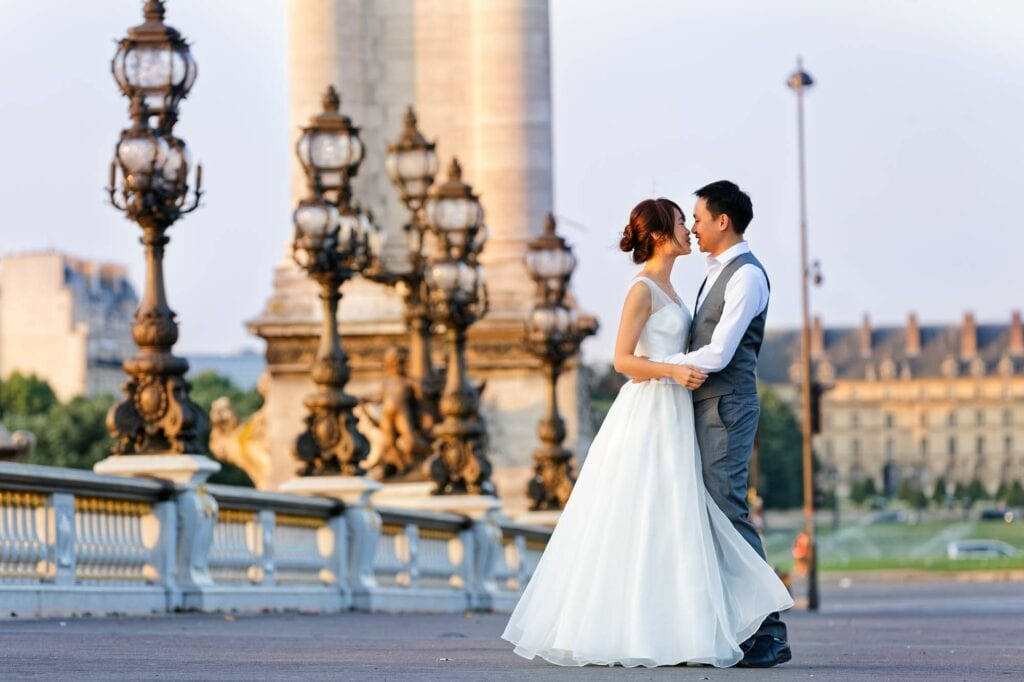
[758,388,804,509]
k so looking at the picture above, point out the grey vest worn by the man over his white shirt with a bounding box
[688,253,771,402]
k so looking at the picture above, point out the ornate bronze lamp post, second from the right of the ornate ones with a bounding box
[425,159,495,495]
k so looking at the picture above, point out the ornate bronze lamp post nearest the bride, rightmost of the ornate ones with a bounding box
[524,214,597,511]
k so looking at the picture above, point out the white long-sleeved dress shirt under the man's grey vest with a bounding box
[651,242,768,383]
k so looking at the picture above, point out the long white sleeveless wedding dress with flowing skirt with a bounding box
[502,278,793,667]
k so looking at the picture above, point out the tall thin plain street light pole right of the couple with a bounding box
[786,57,818,610]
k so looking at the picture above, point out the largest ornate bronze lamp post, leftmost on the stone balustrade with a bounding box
[106,0,206,455]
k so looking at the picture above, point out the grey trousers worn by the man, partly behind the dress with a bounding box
[693,393,786,639]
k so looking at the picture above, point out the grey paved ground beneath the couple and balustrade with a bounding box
[0,582,1024,682]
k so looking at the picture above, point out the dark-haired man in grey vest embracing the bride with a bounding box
[651,180,793,668]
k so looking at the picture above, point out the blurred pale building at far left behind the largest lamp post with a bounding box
[0,252,138,400]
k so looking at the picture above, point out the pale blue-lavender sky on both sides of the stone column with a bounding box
[0,0,1024,360]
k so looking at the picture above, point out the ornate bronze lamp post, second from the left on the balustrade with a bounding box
[293,87,381,476]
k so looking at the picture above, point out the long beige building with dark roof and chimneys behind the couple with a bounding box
[759,311,1024,495]
